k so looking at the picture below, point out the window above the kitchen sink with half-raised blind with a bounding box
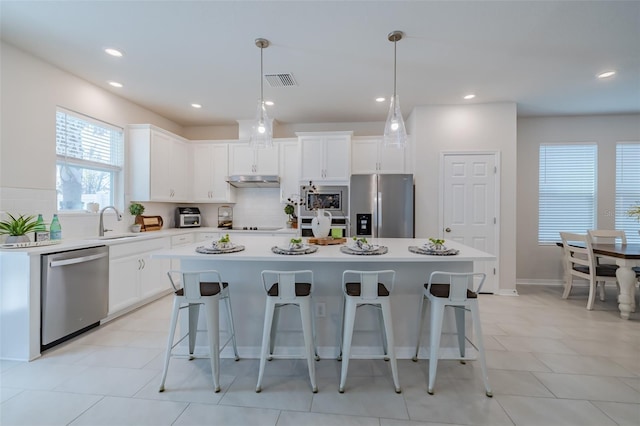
[56,108,124,211]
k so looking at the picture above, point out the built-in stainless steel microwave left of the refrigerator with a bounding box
[300,185,349,217]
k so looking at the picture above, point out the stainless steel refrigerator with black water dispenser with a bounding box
[349,174,414,238]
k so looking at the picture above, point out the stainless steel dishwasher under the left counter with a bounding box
[40,246,109,350]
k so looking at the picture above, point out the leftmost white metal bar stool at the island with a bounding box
[159,270,240,392]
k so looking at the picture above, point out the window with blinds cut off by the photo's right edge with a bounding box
[616,142,640,243]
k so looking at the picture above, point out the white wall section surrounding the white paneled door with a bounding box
[408,103,517,293]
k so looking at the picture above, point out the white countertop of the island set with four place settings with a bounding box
[152,235,496,263]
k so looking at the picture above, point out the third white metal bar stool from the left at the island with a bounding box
[338,270,401,393]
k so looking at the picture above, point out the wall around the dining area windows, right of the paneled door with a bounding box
[516,114,640,283]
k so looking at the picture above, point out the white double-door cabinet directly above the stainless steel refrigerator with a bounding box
[351,137,406,174]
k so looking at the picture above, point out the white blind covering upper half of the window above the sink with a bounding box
[56,108,124,170]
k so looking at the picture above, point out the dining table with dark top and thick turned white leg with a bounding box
[591,243,640,320]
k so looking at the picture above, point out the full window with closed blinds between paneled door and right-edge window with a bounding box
[538,144,598,244]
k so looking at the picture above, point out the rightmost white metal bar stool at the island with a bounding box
[413,271,493,397]
